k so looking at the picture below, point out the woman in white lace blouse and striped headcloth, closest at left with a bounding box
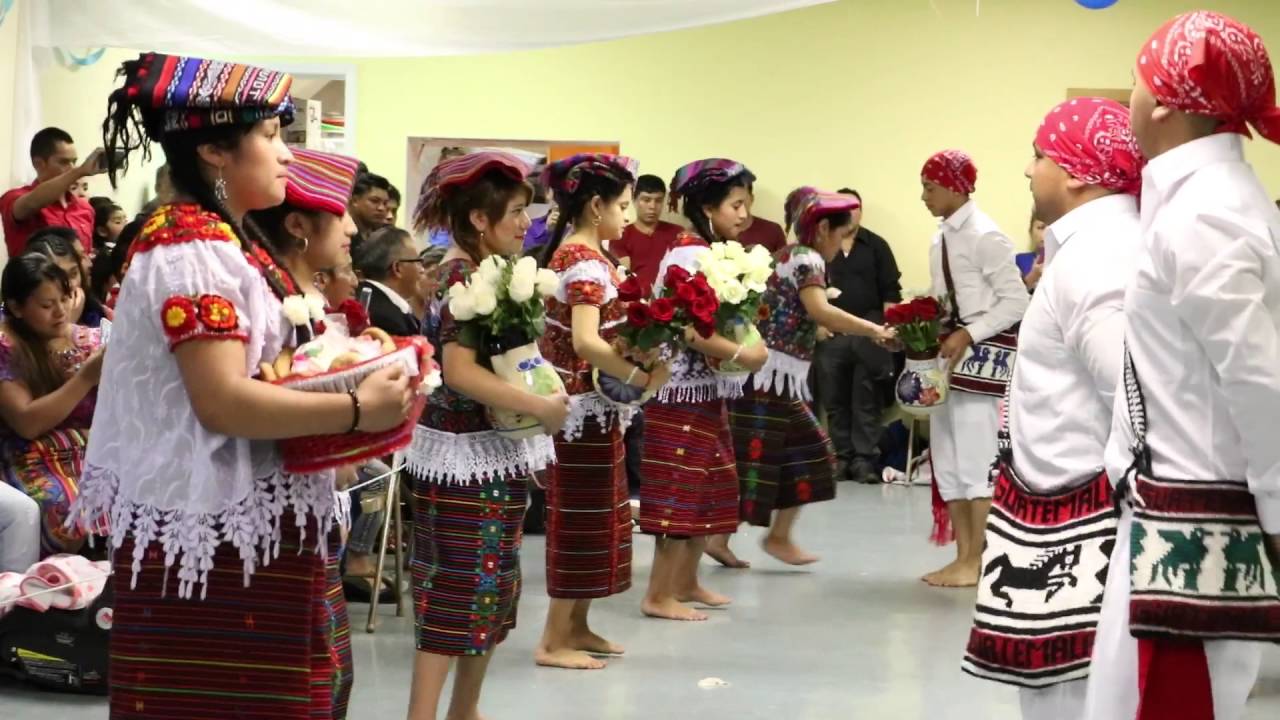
[78,54,412,720]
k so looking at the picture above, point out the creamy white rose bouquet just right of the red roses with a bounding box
[698,241,773,374]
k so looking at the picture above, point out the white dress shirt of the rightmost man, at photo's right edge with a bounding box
[1106,133,1280,533]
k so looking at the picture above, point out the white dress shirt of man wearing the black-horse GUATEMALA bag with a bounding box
[1010,195,1142,493]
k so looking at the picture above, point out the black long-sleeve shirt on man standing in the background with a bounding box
[827,228,902,323]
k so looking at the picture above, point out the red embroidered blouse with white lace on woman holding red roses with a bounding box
[538,243,635,441]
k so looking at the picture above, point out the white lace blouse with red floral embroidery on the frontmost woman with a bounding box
[78,206,335,597]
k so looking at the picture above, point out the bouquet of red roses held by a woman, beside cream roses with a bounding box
[618,265,719,357]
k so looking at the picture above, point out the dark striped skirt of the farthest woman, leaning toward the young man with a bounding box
[730,382,836,527]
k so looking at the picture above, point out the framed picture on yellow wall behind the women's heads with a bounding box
[404,137,621,249]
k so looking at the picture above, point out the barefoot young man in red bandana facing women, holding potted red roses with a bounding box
[920,150,1029,587]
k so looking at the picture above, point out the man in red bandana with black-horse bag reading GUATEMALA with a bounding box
[965,97,1142,720]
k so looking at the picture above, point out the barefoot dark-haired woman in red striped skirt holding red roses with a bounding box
[536,154,669,669]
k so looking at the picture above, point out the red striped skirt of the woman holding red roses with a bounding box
[547,416,631,598]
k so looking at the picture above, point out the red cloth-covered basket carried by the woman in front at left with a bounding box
[275,337,428,473]
